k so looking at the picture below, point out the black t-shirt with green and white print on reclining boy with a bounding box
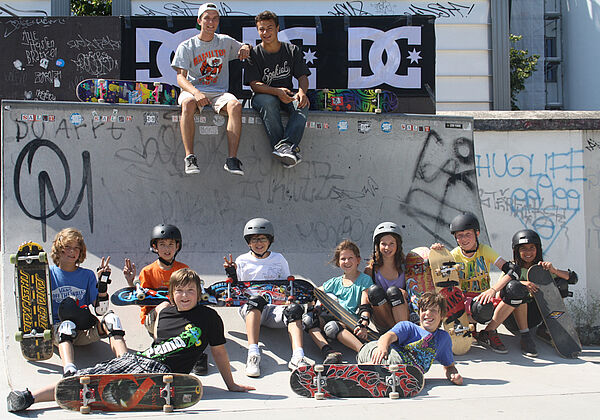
[138,305,225,373]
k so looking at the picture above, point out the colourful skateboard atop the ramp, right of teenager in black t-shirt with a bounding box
[308,89,400,114]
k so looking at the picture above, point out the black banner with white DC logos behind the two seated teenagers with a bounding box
[121,15,435,113]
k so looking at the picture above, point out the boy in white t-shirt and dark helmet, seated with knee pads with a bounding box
[223,218,309,377]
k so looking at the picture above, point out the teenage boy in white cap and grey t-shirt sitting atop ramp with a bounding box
[171,3,250,175]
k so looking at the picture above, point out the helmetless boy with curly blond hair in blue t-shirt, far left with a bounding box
[50,228,127,377]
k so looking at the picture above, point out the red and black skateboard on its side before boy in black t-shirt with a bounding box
[54,373,202,414]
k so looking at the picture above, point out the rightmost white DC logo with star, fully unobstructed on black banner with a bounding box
[348,26,422,89]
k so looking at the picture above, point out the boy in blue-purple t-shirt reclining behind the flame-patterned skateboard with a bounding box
[356,292,463,385]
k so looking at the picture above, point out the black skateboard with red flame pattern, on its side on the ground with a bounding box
[290,364,425,399]
